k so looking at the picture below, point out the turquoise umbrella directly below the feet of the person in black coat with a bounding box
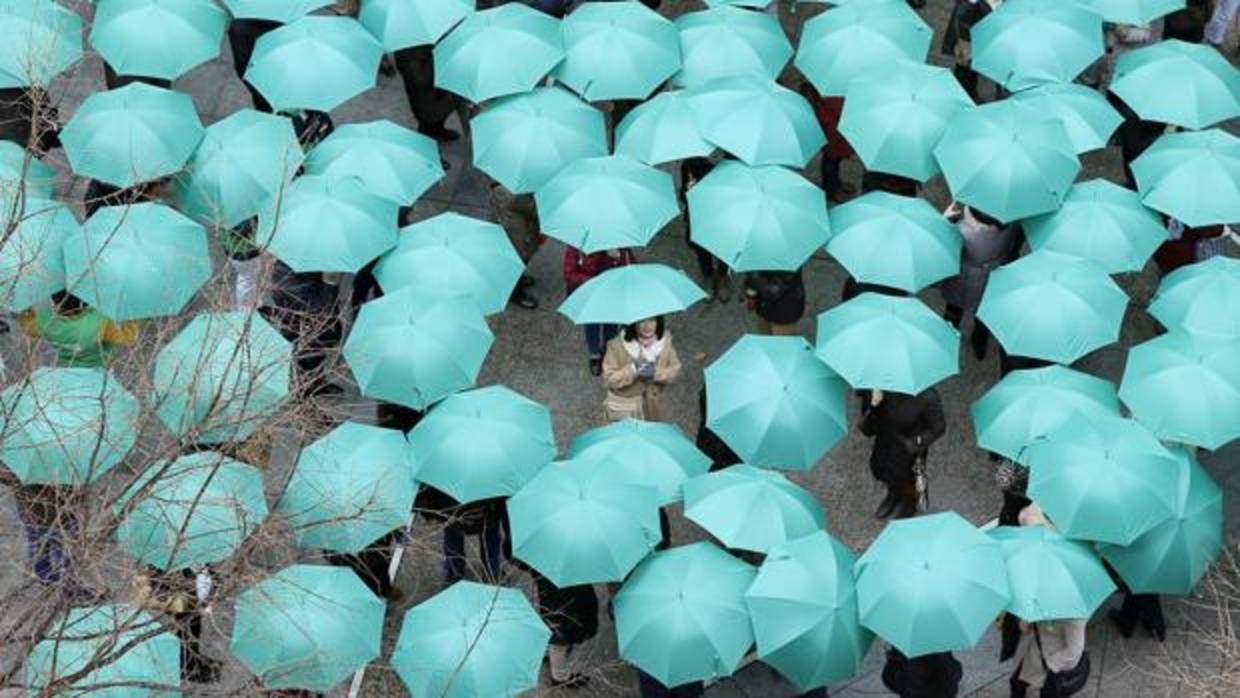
[856,512,1011,657]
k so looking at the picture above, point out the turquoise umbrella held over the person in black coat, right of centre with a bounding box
[816,293,960,395]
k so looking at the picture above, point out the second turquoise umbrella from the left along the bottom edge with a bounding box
[229,564,386,692]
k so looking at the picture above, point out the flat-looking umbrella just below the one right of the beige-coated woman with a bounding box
[684,464,827,553]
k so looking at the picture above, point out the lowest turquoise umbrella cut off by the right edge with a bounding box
[1120,329,1240,450]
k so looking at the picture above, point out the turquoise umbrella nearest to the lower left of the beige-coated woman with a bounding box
[409,386,556,503]
